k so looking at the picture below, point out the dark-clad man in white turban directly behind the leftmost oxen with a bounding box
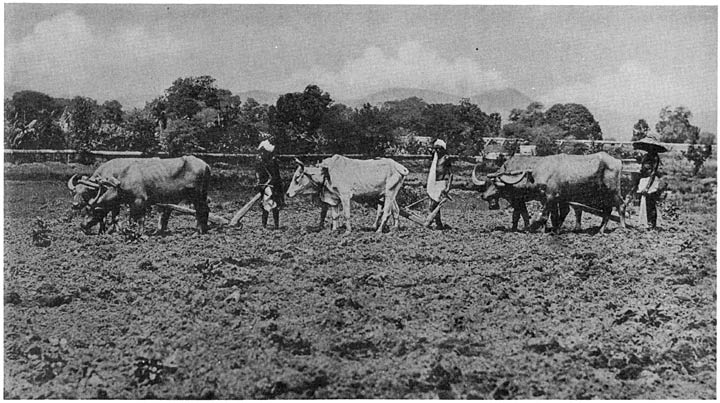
[255,137,285,229]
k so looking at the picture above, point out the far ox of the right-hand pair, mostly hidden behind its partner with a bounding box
[472,155,582,231]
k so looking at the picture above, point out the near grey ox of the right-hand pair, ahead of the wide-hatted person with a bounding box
[476,152,625,233]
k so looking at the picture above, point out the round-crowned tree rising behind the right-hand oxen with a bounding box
[544,103,602,140]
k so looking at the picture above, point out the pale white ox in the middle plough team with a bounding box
[287,155,409,237]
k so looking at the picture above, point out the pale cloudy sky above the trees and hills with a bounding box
[4,3,718,139]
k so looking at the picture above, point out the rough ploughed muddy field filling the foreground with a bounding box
[4,166,717,399]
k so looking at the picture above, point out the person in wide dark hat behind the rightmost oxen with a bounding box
[633,137,667,229]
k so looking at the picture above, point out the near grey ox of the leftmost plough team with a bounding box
[71,156,210,234]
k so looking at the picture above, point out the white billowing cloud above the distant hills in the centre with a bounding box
[277,42,507,98]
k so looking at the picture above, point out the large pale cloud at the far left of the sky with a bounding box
[5,12,182,106]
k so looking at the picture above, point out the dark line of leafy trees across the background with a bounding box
[5,76,714,156]
